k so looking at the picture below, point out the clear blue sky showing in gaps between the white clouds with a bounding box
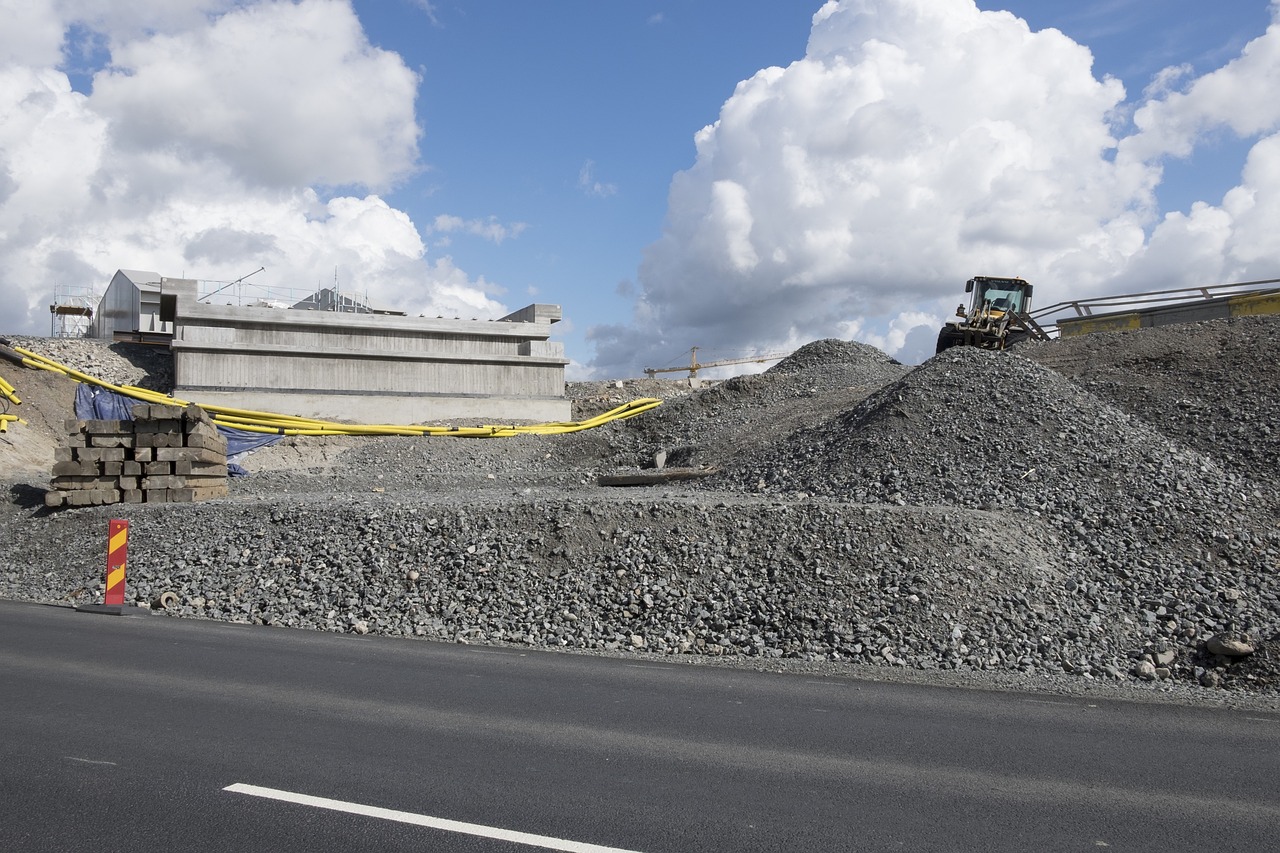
[366,0,1270,371]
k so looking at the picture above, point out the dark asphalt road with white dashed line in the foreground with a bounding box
[0,602,1280,853]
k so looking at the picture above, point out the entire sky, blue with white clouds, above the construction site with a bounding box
[0,0,1280,379]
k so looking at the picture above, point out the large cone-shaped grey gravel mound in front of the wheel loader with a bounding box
[721,347,1247,514]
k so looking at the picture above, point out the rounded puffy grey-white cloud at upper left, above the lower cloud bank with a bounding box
[91,0,419,188]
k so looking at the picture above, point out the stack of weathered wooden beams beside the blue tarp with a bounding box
[45,403,227,507]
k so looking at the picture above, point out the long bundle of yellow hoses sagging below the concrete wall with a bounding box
[10,347,662,438]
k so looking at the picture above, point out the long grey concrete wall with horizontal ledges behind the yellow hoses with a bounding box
[163,279,571,424]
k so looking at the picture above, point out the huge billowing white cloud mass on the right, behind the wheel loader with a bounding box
[589,0,1280,375]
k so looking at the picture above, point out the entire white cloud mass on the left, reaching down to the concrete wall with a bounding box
[0,0,509,332]
